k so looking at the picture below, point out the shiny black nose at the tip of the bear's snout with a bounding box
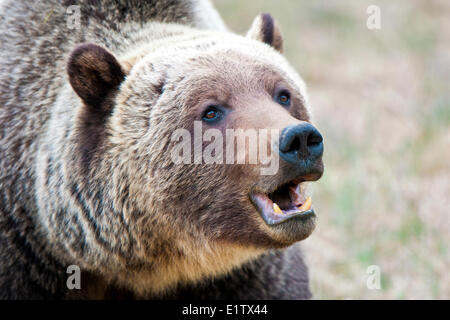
[280,122,323,166]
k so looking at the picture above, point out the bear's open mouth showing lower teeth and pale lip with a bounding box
[250,180,314,225]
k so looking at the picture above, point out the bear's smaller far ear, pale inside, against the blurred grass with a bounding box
[247,13,283,52]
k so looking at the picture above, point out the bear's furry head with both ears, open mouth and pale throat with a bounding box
[62,14,323,291]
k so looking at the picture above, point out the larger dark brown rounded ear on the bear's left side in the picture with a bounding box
[67,43,125,111]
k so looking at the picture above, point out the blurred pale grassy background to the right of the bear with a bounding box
[213,0,450,299]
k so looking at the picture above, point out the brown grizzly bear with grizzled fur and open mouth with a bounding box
[0,0,323,299]
